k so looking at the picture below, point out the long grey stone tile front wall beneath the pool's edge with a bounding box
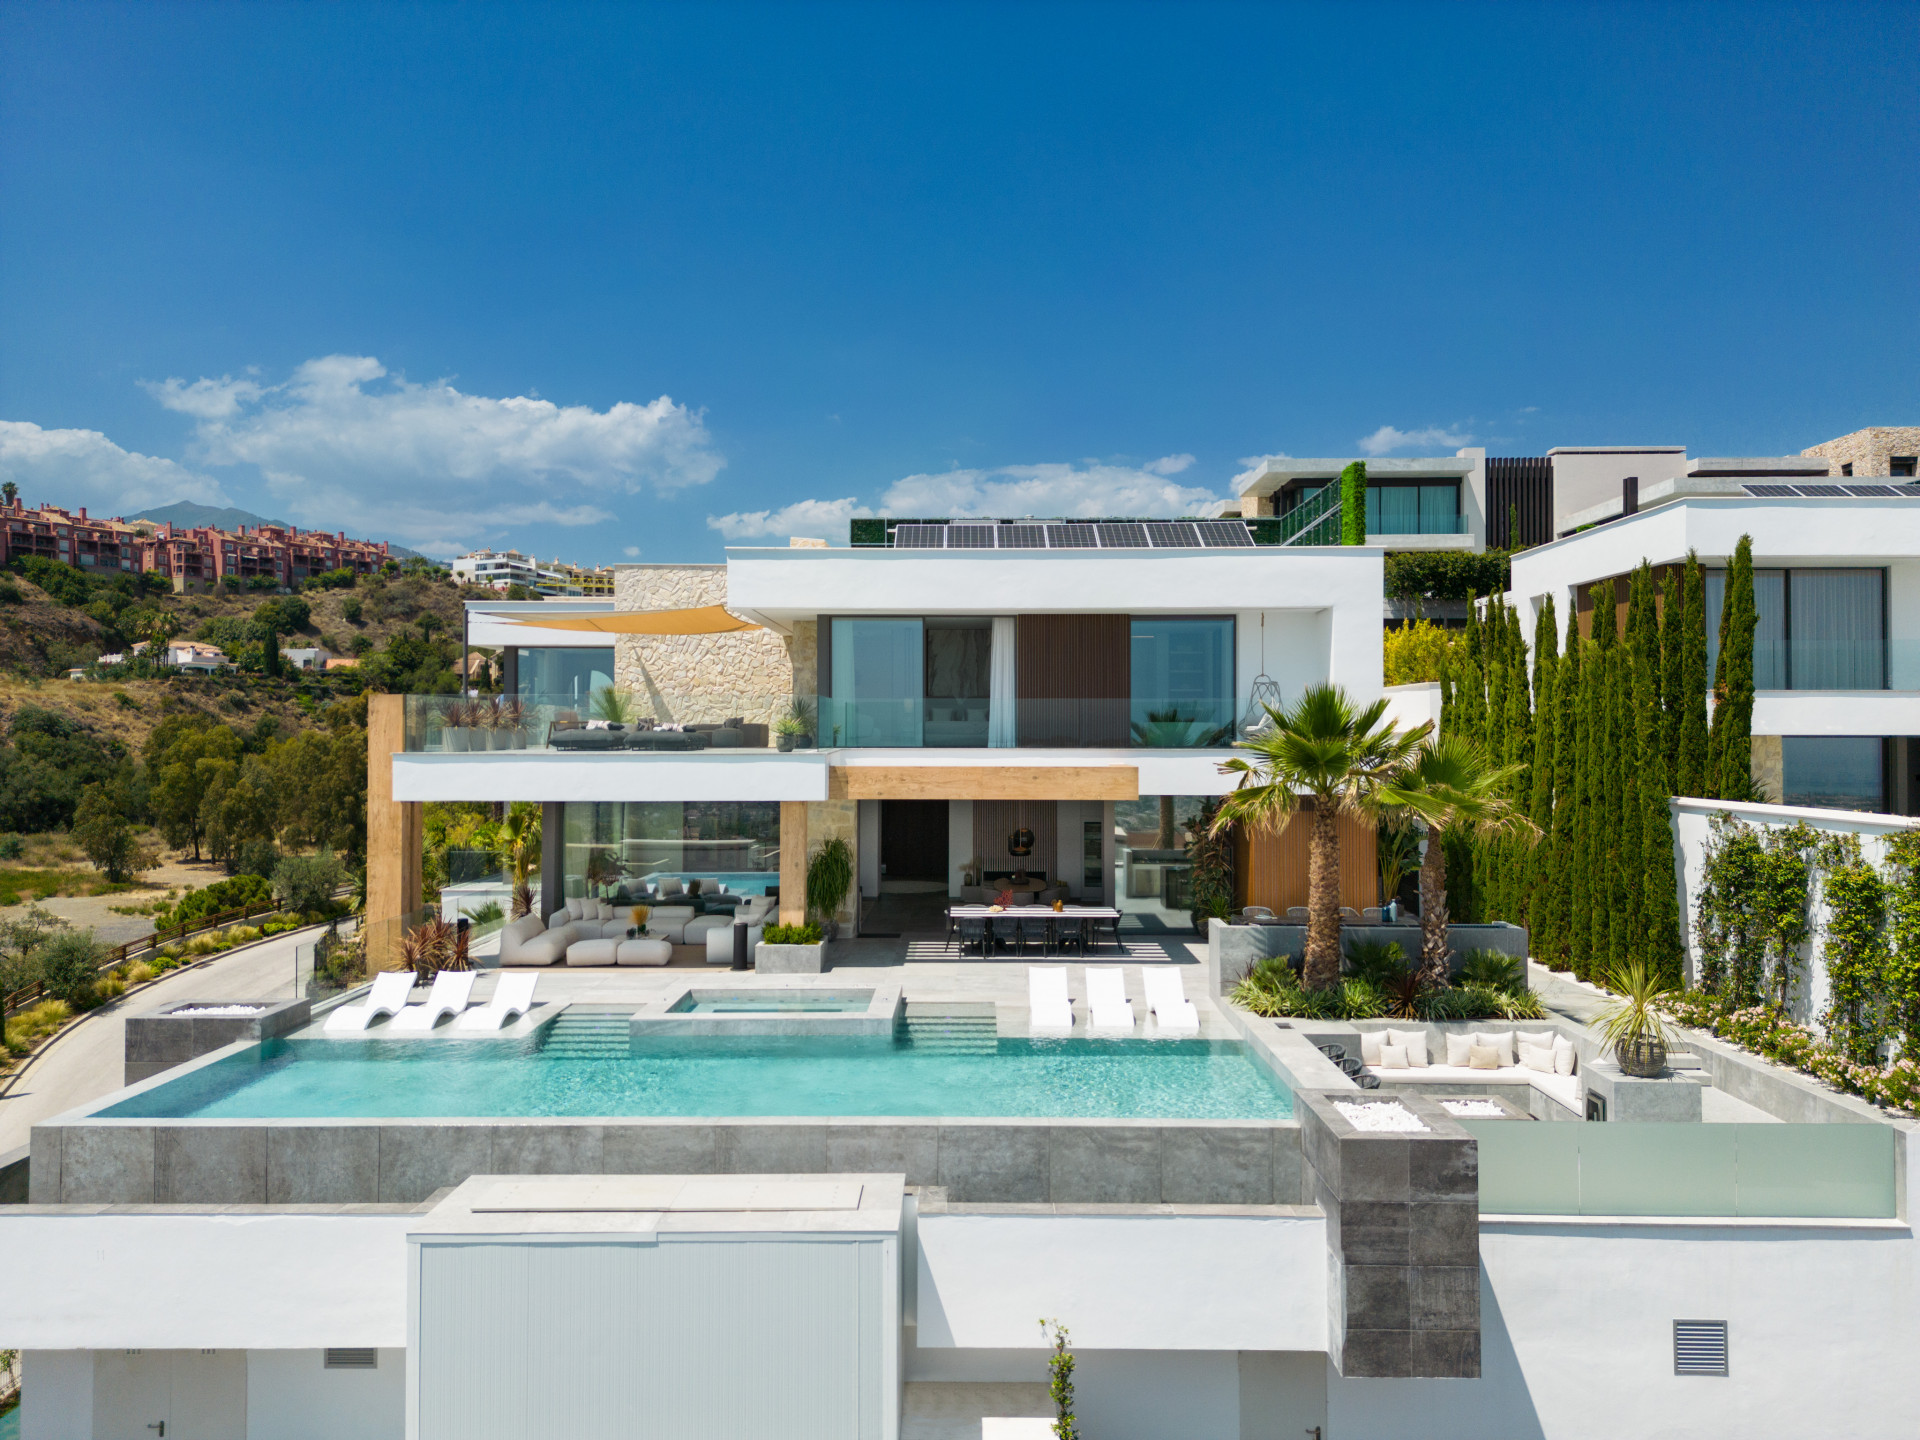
[29,1117,1309,1206]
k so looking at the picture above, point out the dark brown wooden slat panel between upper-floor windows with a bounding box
[1014,614,1133,747]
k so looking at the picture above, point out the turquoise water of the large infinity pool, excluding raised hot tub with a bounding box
[100,1039,1292,1119]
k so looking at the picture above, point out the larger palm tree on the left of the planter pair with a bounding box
[1212,685,1432,991]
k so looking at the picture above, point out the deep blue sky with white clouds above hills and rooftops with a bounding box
[0,0,1920,563]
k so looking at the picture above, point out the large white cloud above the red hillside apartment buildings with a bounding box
[133,355,726,555]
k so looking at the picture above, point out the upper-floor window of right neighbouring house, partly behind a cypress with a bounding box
[1707,568,1887,689]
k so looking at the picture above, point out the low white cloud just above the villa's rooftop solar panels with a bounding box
[707,455,1227,540]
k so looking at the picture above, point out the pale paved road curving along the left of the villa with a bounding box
[0,929,313,1154]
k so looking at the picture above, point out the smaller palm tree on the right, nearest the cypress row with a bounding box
[1377,735,1540,987]
